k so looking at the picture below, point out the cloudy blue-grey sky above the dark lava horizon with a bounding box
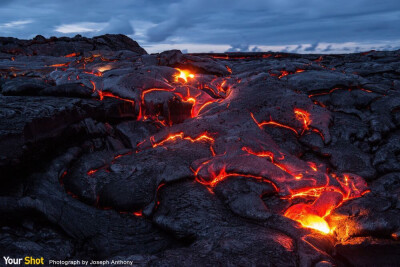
[0,0,400,53]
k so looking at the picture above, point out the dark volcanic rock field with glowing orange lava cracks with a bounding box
[0,35,400,267]
